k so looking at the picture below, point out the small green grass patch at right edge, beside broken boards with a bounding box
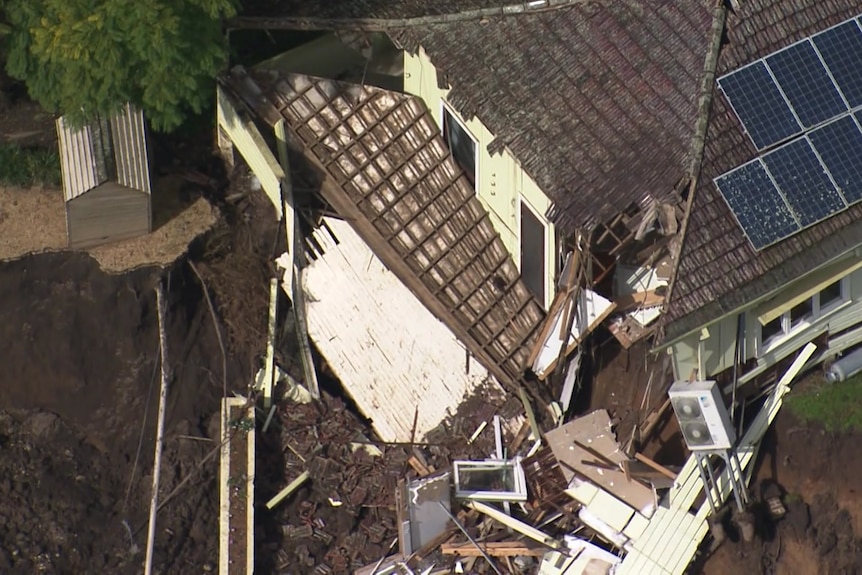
[786,374,862,432]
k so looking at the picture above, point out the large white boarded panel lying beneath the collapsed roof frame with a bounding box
[302,218,503,441]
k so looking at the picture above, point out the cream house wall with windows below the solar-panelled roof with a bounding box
[668,260,862,382]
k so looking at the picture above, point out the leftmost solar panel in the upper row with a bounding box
[718,61,802,150]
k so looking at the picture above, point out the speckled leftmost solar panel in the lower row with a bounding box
[715,160,800,250]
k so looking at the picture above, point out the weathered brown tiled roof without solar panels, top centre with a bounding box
[390,0,715,231]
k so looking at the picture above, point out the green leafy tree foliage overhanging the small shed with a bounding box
[0,0,236,131]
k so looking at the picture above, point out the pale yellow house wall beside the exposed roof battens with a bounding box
[404,48,556,309]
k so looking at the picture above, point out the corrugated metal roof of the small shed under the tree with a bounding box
[57,104,151,202]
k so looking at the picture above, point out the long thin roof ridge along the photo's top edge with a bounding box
[226,0,589,32]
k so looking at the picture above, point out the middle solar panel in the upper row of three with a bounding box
[766,41,847,128]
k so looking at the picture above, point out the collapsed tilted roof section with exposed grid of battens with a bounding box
[223,68,544,400]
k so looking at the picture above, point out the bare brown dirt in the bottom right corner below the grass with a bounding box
[701,410,862,575]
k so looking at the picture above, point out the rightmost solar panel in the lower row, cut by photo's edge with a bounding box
[808,116,862,204]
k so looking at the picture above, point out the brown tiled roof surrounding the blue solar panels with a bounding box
[663,0,862,341]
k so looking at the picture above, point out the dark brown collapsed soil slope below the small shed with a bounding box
[0,253,250,574]
